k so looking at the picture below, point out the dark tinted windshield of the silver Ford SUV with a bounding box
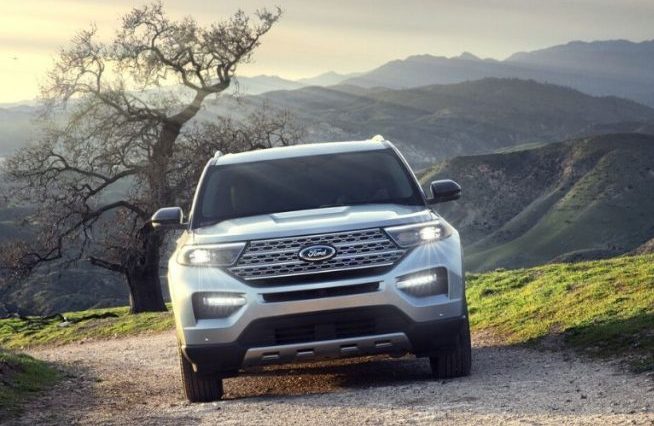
[193,150,424,227]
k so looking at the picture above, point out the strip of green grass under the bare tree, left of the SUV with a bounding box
[0,307,174,349]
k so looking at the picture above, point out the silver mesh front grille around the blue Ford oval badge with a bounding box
[229,228,406,281]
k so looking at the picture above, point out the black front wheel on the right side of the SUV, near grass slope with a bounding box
[429,309,472,379]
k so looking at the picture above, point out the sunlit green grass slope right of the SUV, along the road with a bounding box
[467,255,654,371]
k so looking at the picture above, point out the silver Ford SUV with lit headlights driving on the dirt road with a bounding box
[152,137,471,401]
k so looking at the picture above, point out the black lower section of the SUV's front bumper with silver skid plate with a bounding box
[182,306,464,377]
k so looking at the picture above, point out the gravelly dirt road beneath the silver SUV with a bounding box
[10,333,654,425]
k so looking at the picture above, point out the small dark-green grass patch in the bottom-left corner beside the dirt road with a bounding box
[0,350,60,420]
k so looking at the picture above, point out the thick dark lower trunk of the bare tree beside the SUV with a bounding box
[126,226,167,314]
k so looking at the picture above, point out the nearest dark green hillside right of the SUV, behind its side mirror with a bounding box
[421,134,654,271]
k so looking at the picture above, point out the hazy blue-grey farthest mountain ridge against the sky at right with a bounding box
[343,40,654,106]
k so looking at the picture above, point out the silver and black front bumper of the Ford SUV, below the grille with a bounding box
[168,233,466,375]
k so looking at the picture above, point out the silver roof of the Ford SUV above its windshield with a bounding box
[209,137,392,165]
